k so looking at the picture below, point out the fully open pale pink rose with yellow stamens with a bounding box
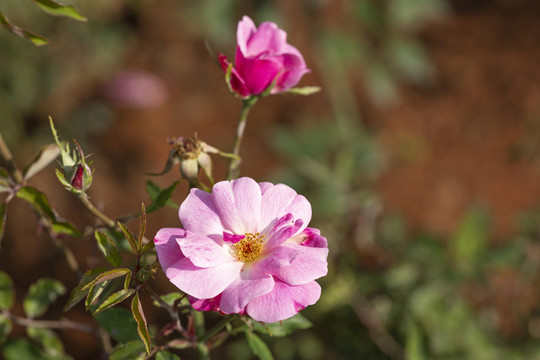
[154,177,328,323]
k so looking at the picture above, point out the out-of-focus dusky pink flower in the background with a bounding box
[105,70,168,109]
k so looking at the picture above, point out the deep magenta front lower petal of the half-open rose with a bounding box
[234,51,283,95]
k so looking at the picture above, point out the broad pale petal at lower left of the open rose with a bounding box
[168,258,243,299]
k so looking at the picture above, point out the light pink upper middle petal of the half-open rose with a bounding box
[244,22,287,58]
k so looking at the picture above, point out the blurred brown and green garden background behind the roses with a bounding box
[0,0,540,360]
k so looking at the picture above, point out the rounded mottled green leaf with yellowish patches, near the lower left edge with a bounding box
[23,278,66,318]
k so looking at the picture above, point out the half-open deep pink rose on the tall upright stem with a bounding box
[218,16,309,97]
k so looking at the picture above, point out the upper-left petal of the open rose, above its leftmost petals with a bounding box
[178,189,224,236]
